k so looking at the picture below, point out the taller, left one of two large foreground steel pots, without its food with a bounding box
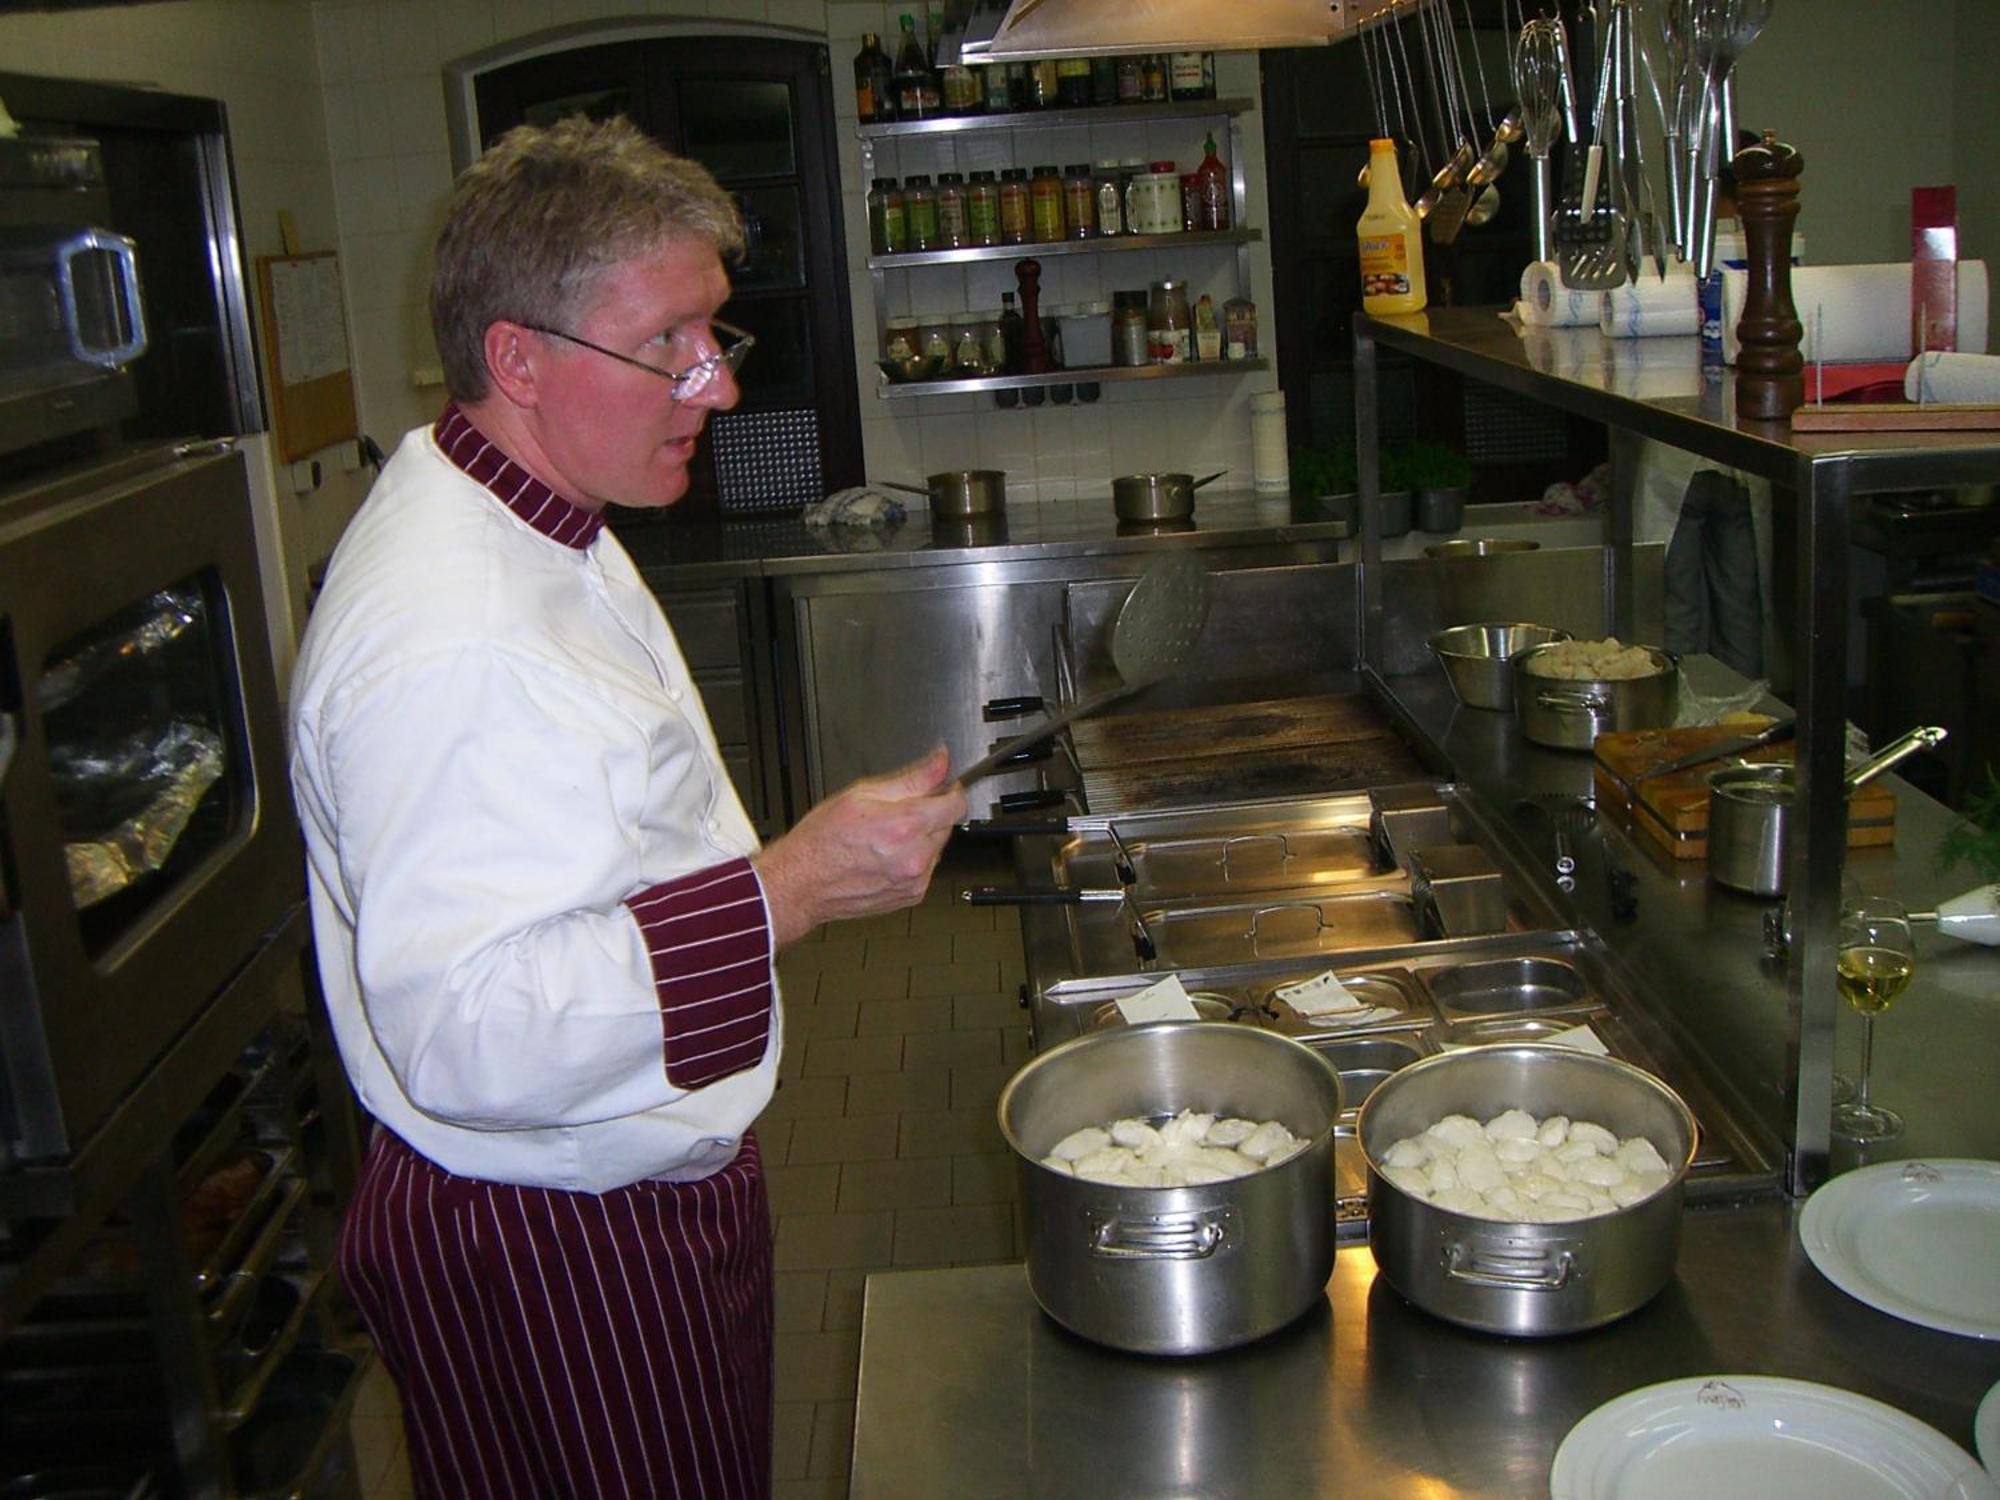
[1000,1022,1340,1354]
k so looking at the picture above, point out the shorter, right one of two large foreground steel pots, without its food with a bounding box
[1360,1028,1696,1336]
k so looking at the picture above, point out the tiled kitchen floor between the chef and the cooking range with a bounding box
[354,844,1028,1500]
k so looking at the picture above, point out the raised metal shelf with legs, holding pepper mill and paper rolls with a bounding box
[1354,308,2000,1194]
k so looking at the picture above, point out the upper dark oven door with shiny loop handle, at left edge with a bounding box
[0,134,146,462]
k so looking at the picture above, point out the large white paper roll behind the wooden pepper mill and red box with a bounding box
[1722,260,1988,364]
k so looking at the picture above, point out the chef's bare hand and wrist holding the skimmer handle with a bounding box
[752,744,966,948]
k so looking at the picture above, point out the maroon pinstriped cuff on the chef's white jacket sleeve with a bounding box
[626,858,772,1088]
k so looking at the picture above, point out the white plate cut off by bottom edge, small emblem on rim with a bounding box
[1548,1376,2000,1500]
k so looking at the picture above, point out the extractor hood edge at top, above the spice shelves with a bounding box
[960,0,1392,62]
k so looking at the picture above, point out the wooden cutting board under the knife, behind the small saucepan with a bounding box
[1592,724,1896,860]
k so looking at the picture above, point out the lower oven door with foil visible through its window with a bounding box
[0,442,304,1168]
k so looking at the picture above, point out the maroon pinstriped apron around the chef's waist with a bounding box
[336,1130,772,1500]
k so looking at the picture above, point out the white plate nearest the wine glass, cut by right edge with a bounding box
[1798,1160,2000,1338]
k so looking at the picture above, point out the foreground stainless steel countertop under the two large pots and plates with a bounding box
[848,1200,2000,1500]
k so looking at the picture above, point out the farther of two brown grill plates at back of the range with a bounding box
[1070,694,1390,768]
